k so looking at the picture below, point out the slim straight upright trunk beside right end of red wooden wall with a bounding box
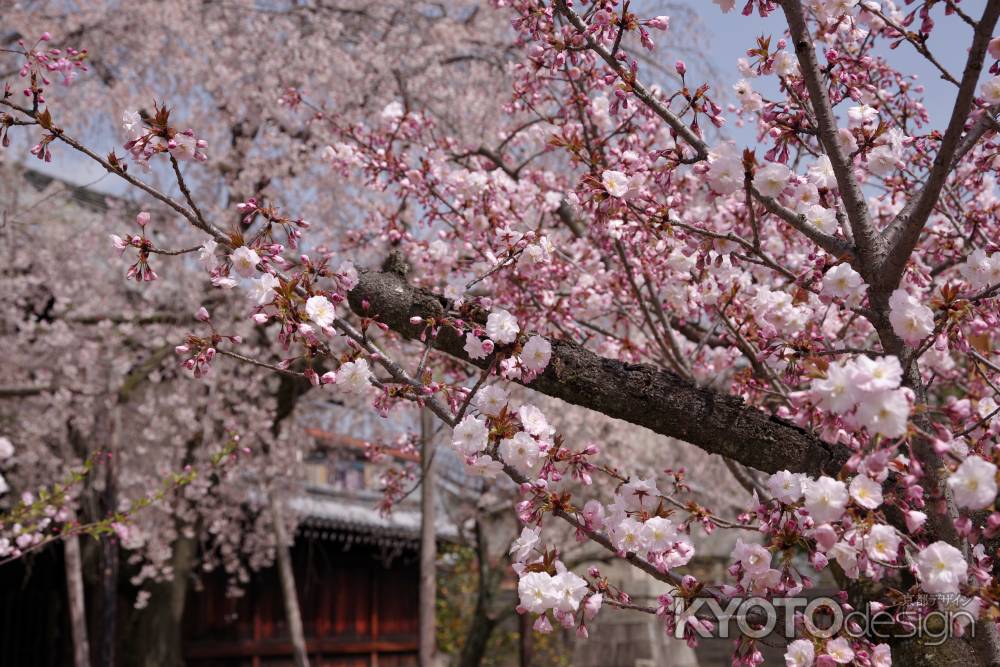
[420,410,437,667]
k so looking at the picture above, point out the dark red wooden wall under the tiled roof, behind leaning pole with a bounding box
[184,534,418,667]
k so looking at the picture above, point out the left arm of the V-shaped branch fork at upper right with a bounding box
[781,0,883,278]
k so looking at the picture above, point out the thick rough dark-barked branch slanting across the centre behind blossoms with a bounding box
[348,271,848,475]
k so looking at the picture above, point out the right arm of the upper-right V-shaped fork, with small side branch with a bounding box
[881,0,1000,288]
